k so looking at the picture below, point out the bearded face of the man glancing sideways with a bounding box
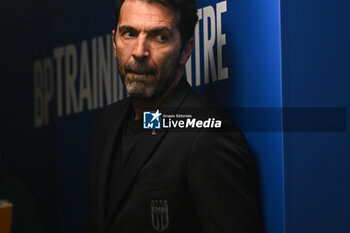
[113,0,186,99]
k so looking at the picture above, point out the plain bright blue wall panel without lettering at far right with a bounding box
[281,0,350,233]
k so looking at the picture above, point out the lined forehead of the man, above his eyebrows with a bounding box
[118,0,177,29]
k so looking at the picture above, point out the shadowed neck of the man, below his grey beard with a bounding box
[132,71,183,120]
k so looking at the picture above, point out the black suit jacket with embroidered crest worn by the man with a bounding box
[87,79,262,233]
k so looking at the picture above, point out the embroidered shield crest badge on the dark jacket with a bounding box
[151,199,169,232]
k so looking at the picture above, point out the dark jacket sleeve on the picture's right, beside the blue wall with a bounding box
[187,125,263,233]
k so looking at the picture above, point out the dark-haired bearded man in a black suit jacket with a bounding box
[87,0,261,233]
